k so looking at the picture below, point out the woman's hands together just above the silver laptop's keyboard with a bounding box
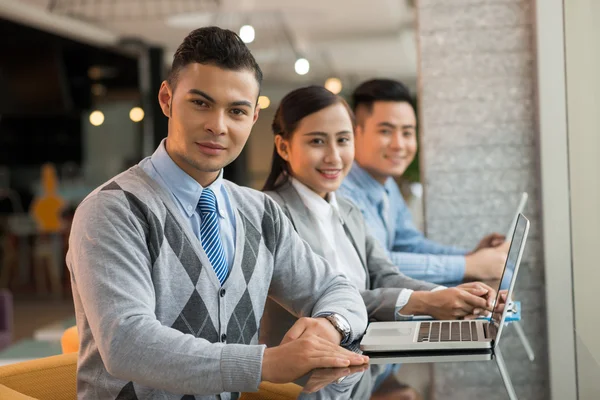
[410,283,495,319]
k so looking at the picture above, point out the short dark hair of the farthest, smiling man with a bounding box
[352,79,415,113]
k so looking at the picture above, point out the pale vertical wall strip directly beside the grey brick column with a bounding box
[535,0,577,400]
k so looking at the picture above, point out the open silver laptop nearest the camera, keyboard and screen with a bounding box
[360,214,529,352]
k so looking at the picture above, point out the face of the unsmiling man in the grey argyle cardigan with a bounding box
[158,63,259,186]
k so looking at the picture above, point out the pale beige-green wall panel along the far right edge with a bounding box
[564,0,600,400]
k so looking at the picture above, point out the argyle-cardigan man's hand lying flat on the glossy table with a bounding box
[261,334,369,383]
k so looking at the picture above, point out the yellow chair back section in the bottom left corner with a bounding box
[0,353,77,400]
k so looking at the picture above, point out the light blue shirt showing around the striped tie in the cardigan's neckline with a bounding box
[139,139,235,271]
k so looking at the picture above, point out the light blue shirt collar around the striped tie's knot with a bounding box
[151,139,223,217]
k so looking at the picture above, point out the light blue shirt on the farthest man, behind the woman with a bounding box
[338,162,467,284]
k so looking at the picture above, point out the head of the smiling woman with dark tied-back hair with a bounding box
[263,86,354,197]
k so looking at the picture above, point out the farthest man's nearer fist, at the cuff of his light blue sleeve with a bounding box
[465,247,510,281]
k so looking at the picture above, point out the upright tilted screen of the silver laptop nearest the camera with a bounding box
[490,214,529,342]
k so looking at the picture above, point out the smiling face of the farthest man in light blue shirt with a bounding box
[355,101,417,183]
